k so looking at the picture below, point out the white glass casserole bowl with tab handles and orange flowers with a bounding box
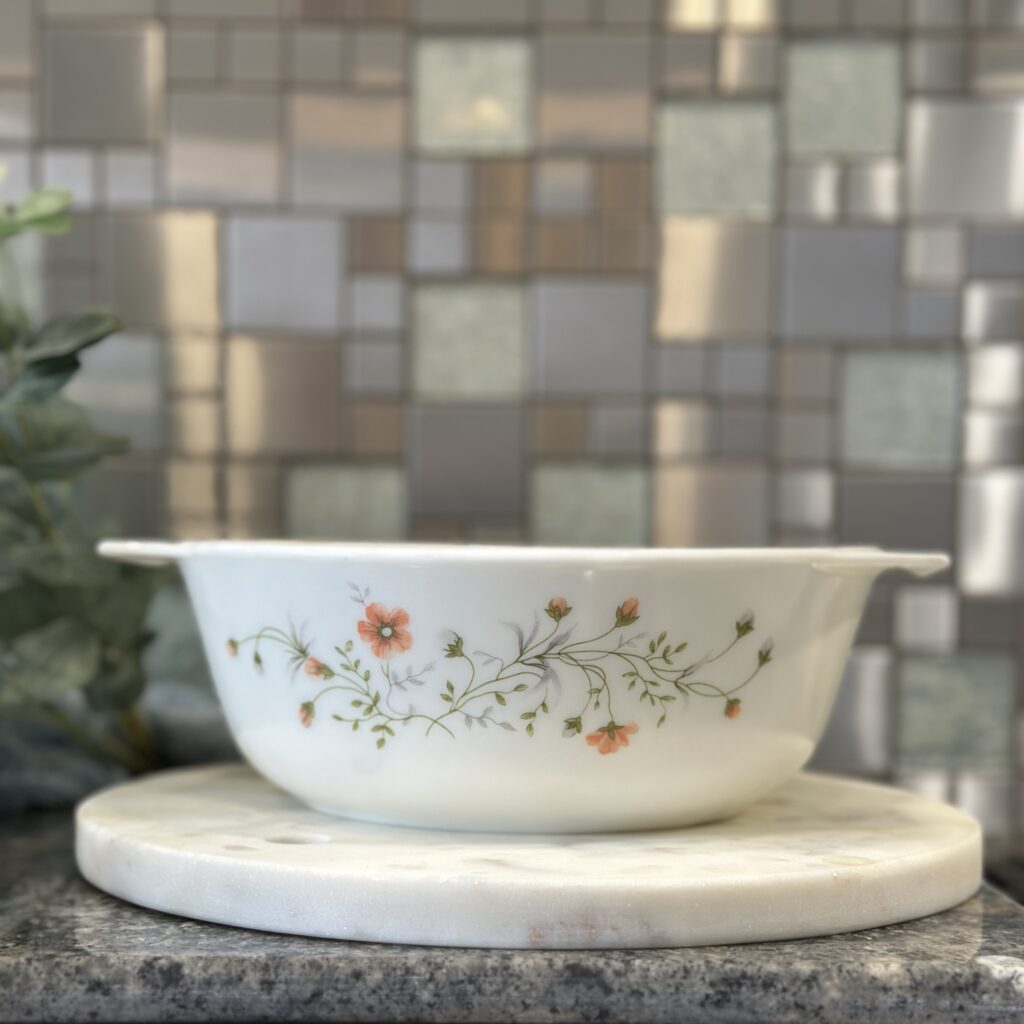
[99,541,949,831]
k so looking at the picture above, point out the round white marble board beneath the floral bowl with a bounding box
[76,765,981,948]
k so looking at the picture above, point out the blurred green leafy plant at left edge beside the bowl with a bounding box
[0,188,158,771]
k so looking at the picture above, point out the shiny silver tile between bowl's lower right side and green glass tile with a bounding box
[808,647,892,775]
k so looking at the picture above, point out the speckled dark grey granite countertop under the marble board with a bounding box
[0,814,1024,1024]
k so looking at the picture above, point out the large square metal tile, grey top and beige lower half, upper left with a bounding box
[166,92,281,203]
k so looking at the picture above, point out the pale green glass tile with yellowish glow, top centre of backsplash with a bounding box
[414,38,532,153]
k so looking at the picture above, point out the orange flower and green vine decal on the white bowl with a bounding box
[225,585,773,755]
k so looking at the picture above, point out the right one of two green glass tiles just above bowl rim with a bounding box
[529,462,648,547]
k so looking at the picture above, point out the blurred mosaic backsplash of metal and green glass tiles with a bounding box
[0,0,1024,836]
